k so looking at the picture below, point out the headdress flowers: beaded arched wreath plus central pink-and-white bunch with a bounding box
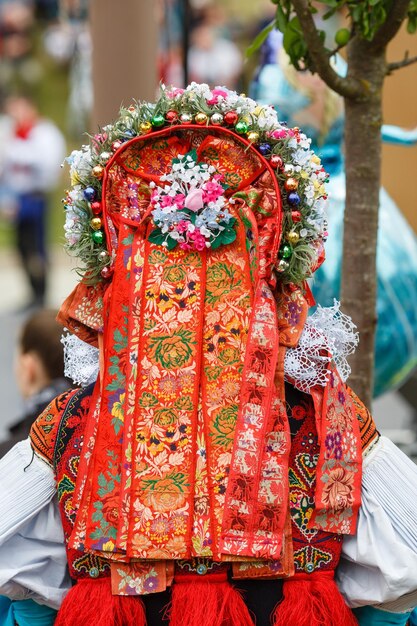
[63,83,327,285]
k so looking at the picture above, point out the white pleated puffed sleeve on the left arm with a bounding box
[0,439,71,608]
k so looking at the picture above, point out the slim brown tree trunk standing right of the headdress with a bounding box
[341,37,385,408]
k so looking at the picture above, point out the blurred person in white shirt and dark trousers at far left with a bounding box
[0,94,65,308]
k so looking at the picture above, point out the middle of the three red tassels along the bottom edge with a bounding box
[167,574,254,626]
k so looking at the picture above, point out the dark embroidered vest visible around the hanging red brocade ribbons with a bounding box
[31,384,378,592]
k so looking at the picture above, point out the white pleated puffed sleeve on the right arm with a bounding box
[337,437,417,612]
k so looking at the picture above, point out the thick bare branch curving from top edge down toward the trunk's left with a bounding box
[293,0,364,99]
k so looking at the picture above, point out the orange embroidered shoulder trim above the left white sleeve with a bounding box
[29,390,77,467]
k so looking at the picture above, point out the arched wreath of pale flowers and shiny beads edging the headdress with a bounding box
[64,83,327,285]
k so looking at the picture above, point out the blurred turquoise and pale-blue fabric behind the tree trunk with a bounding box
[250,42,417,396]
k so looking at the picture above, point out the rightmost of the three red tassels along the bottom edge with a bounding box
[272,572,358,626]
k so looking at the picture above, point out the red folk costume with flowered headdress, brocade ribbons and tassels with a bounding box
[0,84,417,626]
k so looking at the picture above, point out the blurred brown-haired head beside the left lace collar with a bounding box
[15,309,64,398]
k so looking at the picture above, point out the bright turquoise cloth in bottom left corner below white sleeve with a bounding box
[0,596,57,626]
